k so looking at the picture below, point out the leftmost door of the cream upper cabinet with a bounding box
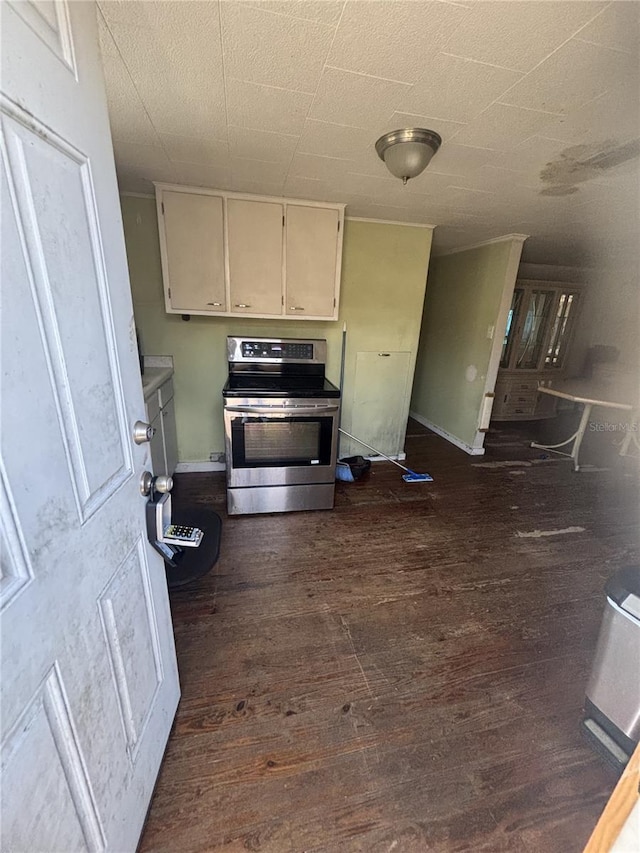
[160,191,227,313]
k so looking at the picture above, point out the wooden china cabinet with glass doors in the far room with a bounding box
[492,280,582,421]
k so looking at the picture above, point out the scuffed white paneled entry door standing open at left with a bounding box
[0,0,179,853]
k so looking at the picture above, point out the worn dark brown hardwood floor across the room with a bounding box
[140,421,640,853]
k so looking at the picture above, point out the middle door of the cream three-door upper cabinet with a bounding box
[227,198,284,315]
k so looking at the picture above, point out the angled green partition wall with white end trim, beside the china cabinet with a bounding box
[411,241,512,446]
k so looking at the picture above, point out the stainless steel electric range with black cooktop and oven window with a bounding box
[222,337,340,515]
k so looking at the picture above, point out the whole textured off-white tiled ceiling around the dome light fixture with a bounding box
[98,0,640,260]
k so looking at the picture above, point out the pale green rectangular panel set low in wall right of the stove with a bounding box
[348,352,411,456]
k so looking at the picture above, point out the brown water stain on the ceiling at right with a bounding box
[540,139,640,196]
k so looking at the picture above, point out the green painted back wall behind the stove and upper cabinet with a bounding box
[121,196,431,462]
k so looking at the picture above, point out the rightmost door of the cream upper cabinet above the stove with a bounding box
[285,204,340,317]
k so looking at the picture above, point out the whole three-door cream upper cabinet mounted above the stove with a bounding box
[156,184,345,320]
